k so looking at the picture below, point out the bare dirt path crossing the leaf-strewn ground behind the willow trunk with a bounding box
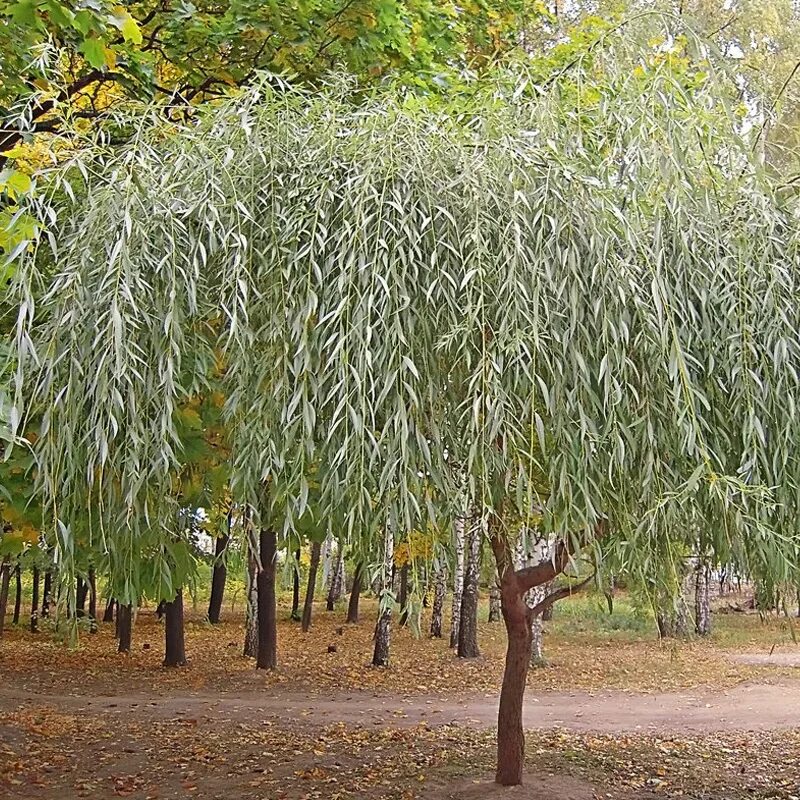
[0,681,800,733]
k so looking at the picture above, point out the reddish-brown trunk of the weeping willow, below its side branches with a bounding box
[495,576,531,786]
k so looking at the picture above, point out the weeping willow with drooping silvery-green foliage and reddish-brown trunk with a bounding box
[9,18,800,784]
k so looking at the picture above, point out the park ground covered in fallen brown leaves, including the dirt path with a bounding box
[0,603,800,800]
